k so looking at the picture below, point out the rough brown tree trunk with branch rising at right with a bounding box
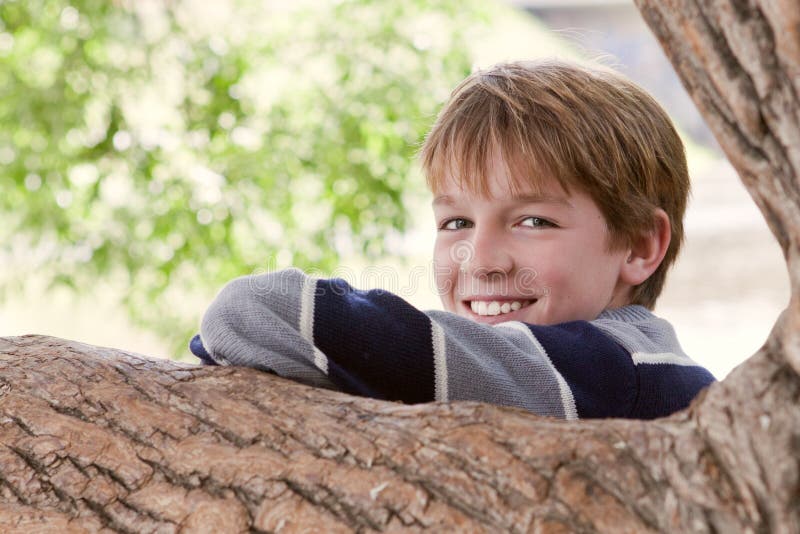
[0,0,800,532]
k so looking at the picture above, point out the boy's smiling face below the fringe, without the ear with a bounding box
[433,164,630,324]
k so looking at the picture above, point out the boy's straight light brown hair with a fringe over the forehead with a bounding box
[420,60,689,308]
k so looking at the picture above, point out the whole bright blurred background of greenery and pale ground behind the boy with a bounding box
[0,0,788,377]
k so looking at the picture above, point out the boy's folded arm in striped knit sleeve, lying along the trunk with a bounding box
[195,270,636,418]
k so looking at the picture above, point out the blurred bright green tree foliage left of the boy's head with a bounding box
[0,0,489,352]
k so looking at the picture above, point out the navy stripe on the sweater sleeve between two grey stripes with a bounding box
[314,278,435,403]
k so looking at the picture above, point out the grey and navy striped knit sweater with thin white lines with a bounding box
[190,269,714,419]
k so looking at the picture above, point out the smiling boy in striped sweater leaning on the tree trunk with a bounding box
[191,61,714,419]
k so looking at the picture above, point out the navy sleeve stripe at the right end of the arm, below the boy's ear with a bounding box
[527,321,637,418]
